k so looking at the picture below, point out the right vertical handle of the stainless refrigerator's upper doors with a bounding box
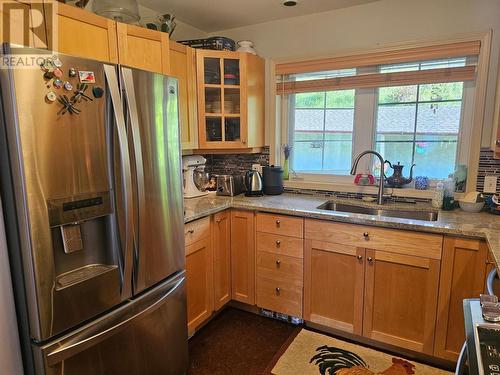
[120,67,146,288]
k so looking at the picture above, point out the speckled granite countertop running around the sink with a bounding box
[184,193,500,271]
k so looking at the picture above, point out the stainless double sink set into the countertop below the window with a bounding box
[317,201,438,221]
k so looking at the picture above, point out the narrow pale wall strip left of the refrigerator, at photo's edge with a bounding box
[0,202,23,375]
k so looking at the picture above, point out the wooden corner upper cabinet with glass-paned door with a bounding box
[196,50,265,150]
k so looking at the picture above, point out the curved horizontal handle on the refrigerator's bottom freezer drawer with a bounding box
[45,275,185,366]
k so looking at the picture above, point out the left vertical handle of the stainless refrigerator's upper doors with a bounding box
[104,65,134,296]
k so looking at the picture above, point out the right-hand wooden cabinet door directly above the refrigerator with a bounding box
[116,22,170,74]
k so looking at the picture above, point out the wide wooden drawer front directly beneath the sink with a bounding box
[305,219,443,259]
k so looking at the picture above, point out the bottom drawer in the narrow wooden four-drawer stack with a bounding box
[257,277,302,318]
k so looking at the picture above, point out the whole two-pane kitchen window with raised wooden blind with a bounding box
[276,40,478,191]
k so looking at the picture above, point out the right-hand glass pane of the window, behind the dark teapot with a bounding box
[373,59,465,179]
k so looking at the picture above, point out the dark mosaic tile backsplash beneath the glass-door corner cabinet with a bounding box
[203,147,269,174]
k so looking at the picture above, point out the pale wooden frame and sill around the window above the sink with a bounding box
[269,31,492,198]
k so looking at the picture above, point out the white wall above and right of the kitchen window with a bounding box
[212,0,500,147]
